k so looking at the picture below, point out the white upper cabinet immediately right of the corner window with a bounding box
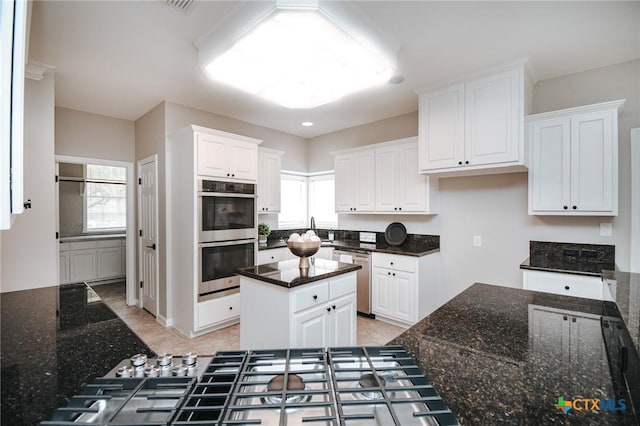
[335,150,375,213]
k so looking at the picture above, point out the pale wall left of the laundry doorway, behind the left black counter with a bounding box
[0,74,58,292]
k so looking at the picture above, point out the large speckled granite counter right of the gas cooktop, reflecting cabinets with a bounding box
[390,284,635,425]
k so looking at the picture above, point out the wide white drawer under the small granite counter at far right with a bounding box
[523,270,603,300]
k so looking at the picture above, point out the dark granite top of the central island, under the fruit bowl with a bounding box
[236,258,362,288]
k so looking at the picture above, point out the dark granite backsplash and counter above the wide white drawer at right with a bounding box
[520,241,616,276]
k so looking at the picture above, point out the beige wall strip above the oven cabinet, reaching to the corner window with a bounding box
[166,102,308,172]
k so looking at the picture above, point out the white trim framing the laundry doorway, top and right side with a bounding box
[54,155,137,305]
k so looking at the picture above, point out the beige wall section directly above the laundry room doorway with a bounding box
[55,107,135,161]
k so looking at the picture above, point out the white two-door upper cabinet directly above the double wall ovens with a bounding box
[198,126,262,182]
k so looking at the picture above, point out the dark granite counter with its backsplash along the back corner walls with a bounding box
[258,229,440,256]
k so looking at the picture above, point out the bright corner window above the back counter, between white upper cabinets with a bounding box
[278,172,338,229]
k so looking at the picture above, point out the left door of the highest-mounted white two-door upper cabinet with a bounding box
[419,84,464,170]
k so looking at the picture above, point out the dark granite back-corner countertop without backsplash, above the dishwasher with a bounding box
[258,236,440,257]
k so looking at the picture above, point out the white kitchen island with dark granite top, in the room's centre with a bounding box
[236,258,362,349]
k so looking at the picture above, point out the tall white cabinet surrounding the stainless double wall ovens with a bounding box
[166,125,262,337]
